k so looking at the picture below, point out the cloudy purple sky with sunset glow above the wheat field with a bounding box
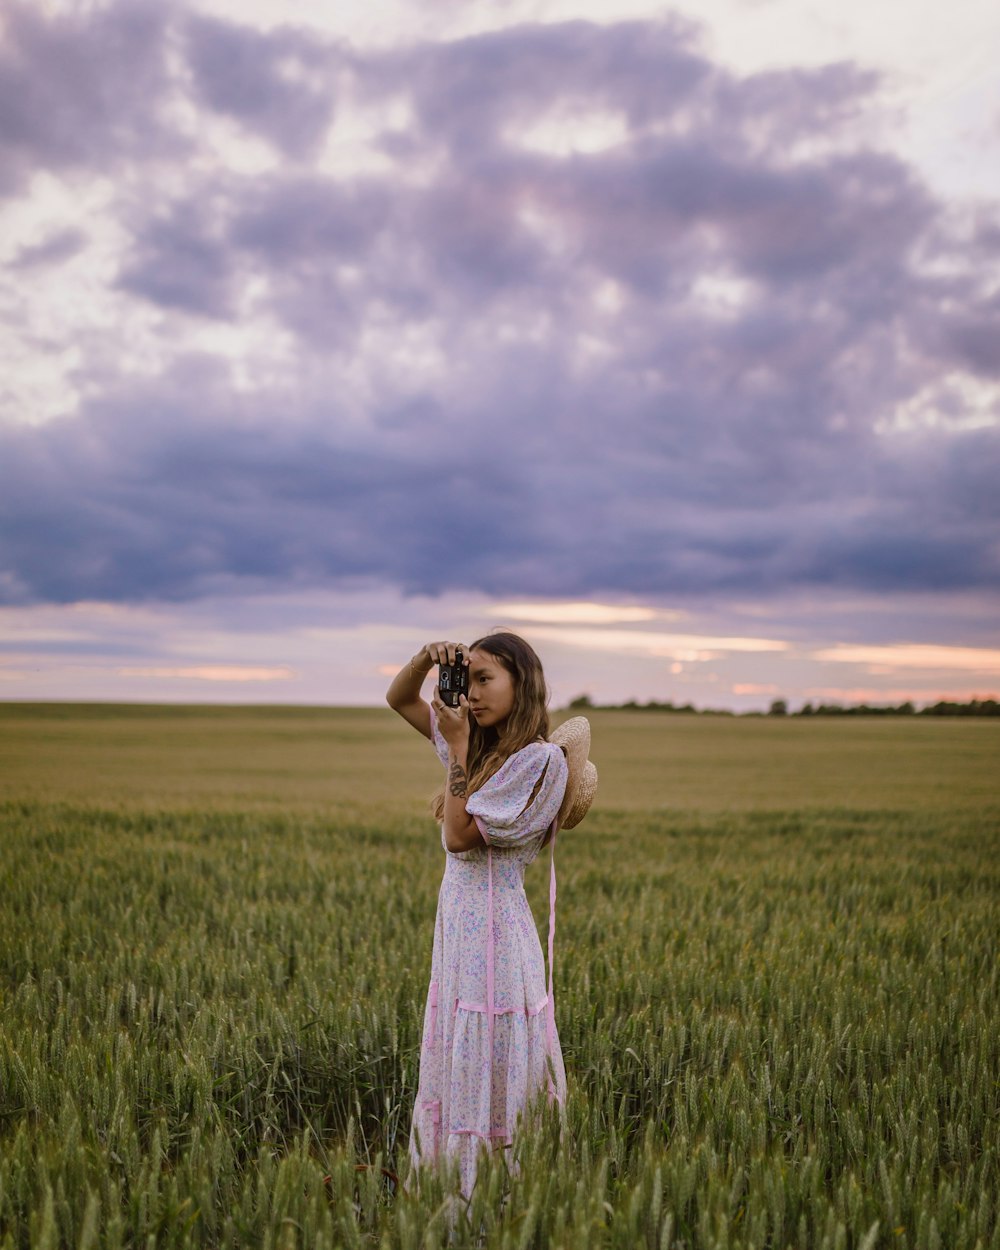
[0,0,1000,710]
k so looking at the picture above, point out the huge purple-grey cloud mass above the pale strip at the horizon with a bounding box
[0,3,1000,605]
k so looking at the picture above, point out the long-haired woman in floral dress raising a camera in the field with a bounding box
[386,633,568,1198]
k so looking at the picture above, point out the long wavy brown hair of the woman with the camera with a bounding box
[431,631,549,840]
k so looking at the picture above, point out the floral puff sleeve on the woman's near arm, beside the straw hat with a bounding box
[465,743,569,846]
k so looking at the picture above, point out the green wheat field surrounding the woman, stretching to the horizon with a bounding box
[0,704,1000,1250]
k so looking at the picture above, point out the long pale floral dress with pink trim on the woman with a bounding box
[410,711,568,1198]
